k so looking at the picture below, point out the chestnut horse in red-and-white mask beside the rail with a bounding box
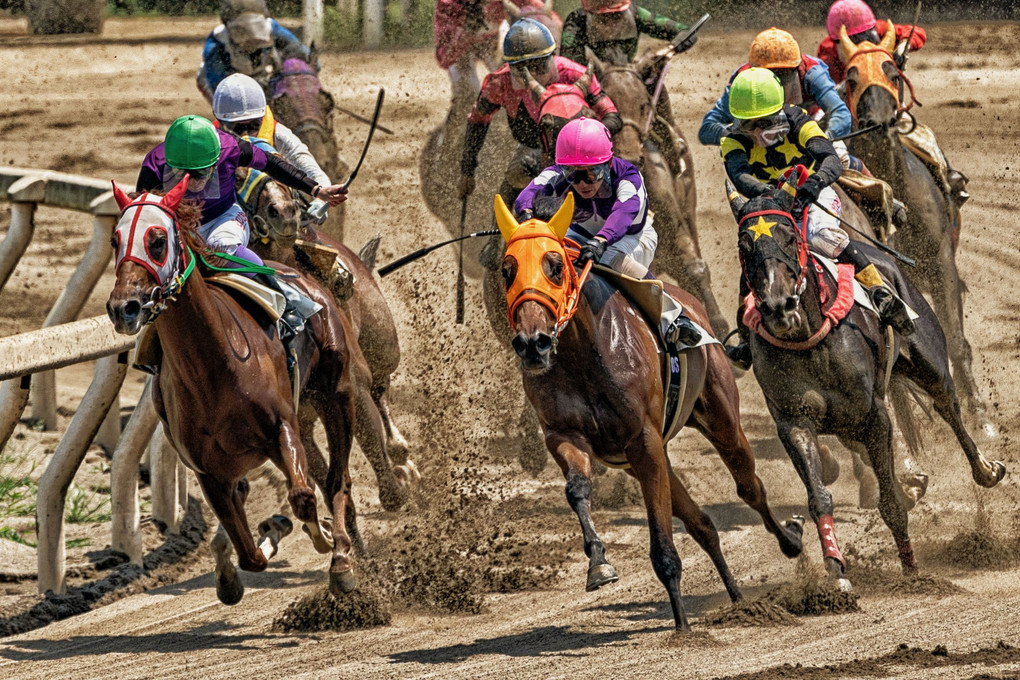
[106,176,356,605]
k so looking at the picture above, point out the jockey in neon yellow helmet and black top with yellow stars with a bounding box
[720,67,914,370]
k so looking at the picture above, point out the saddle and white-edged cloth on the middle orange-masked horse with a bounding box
[593,264,719,442]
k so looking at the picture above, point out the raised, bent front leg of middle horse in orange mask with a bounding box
[546,432,620,592]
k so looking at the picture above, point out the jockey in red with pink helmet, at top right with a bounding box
[818,0,970,207]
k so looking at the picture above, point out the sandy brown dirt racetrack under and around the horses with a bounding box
[0,15,1020,680]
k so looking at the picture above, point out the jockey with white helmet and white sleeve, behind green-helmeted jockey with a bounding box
[212,73,333,214]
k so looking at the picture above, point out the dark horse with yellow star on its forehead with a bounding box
[730,186,1006,589]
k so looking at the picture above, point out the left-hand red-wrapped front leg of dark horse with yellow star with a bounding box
[776,417,851,590]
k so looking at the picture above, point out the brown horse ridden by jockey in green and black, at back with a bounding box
[588,50,729,336]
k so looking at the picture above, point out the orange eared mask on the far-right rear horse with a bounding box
[839,21,920,122]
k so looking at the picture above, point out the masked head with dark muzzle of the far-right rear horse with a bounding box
[839,21,913,128]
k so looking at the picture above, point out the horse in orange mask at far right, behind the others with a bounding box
[840,23,996,436]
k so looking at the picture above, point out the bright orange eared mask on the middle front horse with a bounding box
[496,194,592,334]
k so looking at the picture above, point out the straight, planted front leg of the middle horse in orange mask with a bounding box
[627,423,689,631]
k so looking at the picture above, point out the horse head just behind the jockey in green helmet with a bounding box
[234,167,301,250]
